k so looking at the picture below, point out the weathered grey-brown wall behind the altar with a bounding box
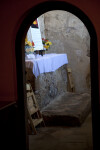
[40,10,90,92]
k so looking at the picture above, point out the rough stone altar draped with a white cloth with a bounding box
[25,53,68,109]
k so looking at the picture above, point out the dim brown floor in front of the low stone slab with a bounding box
[29,113,93,150]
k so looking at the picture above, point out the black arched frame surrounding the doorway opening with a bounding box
[16,1,99,149]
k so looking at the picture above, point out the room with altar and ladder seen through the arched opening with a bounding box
[25,10,93,150]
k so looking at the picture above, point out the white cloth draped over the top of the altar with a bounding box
[25,53,68,78]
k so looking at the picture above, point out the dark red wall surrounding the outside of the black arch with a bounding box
[0,0,100,101]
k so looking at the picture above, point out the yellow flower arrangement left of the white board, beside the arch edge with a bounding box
[25,36,34,53]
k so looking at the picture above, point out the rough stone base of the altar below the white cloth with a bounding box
[26,65,67,109]
